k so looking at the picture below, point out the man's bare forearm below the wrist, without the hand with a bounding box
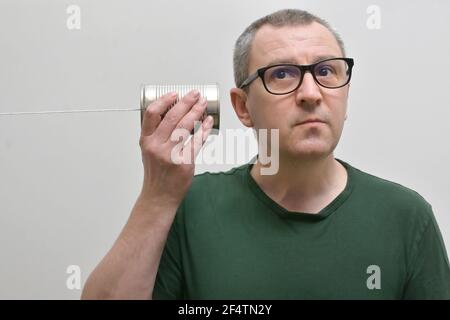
[81,195,177,299]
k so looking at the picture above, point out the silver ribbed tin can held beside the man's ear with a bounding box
[141,84,220,134]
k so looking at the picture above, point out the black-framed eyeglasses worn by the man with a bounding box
[239,58,354,95]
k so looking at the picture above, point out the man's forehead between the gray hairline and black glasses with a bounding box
[249,22,342,72]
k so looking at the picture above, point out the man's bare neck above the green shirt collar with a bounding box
[250,154,347,213]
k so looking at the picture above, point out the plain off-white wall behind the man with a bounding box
[0,0,450,299]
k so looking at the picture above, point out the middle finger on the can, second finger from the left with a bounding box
[155,90,200,141]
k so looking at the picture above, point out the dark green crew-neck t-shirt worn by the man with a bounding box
[153,159,450,299]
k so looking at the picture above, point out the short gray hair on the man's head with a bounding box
[233,9,345,90]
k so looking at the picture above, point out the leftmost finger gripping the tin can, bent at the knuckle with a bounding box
[141,92,177,136]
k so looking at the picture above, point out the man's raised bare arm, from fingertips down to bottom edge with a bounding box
[81,92,213,299]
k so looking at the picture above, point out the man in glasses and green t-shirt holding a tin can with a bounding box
[83,10,450,299]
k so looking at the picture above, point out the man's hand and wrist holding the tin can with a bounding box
[139,90,213,209]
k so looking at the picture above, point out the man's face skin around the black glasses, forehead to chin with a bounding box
[246,22,349,160]
